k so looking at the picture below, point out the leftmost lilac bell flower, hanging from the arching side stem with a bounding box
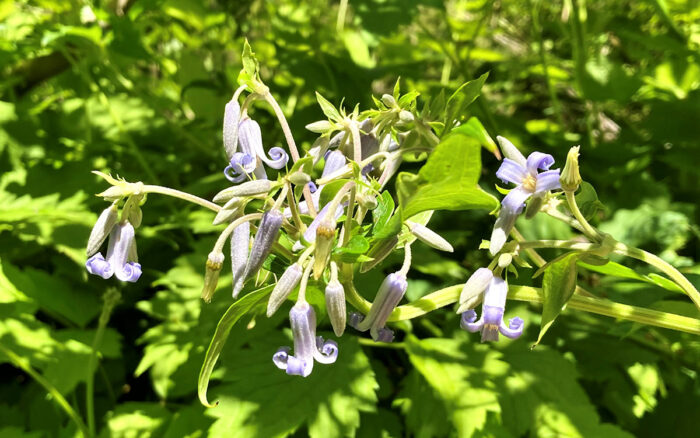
[85,221,141,283]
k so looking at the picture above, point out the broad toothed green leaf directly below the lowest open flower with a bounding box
[209,330,378,438]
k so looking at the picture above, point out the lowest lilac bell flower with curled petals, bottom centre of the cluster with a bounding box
[272,299,338,377]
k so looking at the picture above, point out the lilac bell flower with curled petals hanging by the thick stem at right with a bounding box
[461,277,524,342]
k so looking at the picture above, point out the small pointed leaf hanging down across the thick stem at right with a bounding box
[535,253,579,345]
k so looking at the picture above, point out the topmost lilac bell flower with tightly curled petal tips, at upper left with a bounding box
[224,117,289,183]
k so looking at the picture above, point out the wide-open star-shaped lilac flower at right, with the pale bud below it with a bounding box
[489,137,560,255]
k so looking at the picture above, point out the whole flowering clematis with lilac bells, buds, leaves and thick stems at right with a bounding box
[86,43,700,406]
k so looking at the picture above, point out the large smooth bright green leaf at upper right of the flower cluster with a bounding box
[397,132,498,217]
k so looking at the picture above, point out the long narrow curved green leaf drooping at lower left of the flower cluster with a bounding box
[197,285,274,408]
